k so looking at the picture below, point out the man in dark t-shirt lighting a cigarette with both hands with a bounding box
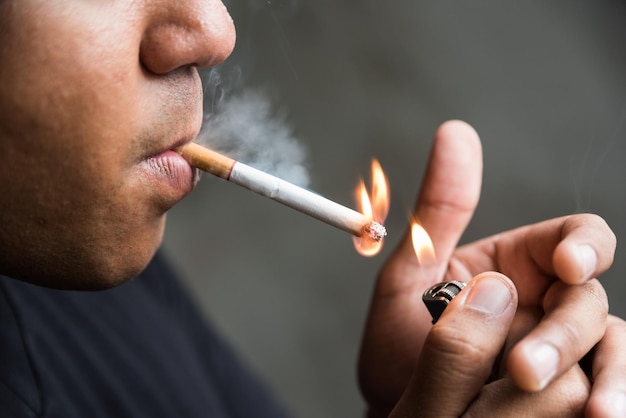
[0,0,626,417]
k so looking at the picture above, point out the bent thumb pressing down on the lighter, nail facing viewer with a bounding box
[390,272,517,417]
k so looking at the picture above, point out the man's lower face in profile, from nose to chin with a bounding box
[0,0,235,288]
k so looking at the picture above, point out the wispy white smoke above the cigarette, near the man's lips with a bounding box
[198,68,309,187]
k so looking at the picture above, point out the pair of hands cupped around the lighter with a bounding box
[359,121,626,417]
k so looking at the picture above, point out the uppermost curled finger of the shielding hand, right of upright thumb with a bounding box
[455,213,617,290]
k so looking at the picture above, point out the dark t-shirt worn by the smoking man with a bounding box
[0,255,285,418]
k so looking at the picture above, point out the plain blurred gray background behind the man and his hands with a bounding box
[165,0,626,417]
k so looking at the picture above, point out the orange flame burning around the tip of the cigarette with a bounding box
[353,159,389,257]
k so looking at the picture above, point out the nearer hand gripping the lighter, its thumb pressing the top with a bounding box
[390,272,589,418]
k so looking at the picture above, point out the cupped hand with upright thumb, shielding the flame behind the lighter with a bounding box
[359,122,621,414]
